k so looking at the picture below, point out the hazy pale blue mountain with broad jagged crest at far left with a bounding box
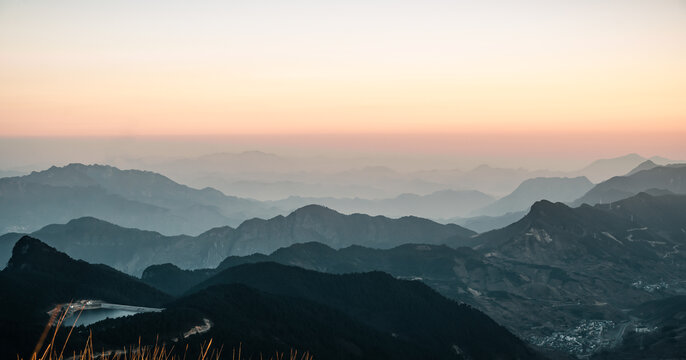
[0,164,279,235]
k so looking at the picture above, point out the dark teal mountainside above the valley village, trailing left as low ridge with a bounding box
[142,193,686,355]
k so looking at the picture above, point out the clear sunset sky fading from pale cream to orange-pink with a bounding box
[0,0,686,158]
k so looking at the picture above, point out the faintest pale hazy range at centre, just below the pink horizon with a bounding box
[146,151,456,201]
